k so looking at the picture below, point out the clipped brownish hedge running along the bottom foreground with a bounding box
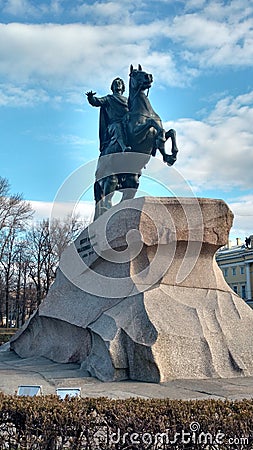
[0,393,253,450]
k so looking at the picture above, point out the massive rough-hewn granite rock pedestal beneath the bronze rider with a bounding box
[11,197,253,382]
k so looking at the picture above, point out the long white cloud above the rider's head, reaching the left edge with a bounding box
[0,22,188,89]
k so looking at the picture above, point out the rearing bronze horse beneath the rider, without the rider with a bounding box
[94,64,178,219]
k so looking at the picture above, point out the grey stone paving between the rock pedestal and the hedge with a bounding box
[0,347,253,400]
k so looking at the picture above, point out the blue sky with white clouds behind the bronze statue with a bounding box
[0,0,253,239]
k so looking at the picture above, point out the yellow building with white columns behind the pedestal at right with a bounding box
[216,235,253,303]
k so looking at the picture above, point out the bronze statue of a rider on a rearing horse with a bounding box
[86,65,178,219]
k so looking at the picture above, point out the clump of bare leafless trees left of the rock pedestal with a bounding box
[0,177,85,327]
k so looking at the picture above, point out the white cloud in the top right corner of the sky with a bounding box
[167,0,253,68]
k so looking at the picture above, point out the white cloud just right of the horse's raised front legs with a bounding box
[165,92,253,192]
